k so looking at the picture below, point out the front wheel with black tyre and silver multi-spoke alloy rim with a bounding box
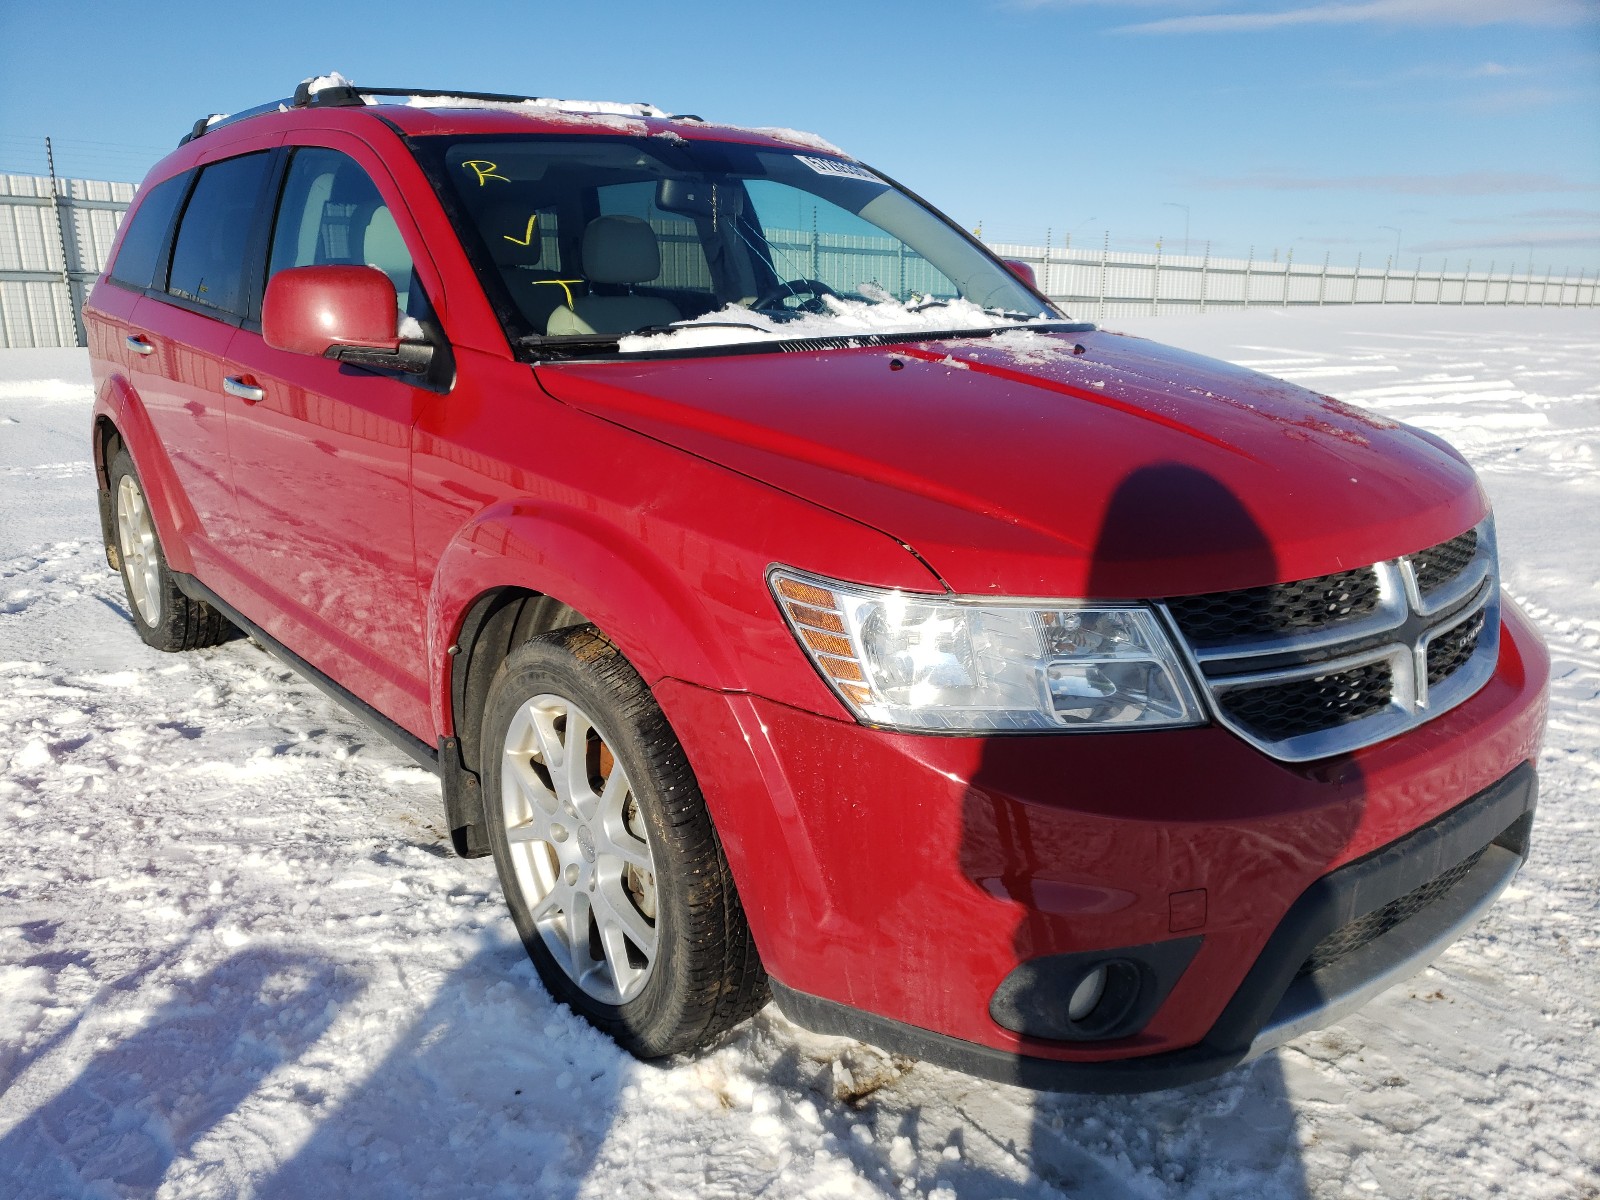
[483,626,766,1058]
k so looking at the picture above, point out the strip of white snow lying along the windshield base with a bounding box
[618,296,1058,354]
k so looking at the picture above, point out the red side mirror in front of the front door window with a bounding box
[261,266,434,374]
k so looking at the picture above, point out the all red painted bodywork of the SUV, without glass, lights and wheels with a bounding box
[85,96,1547,1081]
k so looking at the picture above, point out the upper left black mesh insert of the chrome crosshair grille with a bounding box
[1166,566,1378,646]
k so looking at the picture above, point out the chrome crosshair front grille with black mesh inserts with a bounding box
[1162,520,1499,762]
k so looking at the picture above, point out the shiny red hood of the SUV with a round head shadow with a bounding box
[536,331,1488,598]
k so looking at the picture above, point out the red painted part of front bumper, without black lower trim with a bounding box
[656,605,1549,1061]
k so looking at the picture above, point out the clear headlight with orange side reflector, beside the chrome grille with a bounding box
[768,568,1205,733]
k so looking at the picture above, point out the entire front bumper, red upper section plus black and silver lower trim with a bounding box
[656,605,1549,1090]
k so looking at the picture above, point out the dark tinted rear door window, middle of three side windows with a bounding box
[166,154,270,314]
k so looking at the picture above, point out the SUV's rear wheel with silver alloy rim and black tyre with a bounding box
[110,450,234,651]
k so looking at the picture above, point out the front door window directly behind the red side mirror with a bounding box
[267,147,422,315]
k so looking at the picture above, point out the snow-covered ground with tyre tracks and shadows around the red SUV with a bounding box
[0,309,1600,1200]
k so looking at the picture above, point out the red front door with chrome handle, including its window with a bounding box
[226,133,434,739]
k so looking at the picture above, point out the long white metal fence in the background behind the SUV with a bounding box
[0,174,1600,347]
